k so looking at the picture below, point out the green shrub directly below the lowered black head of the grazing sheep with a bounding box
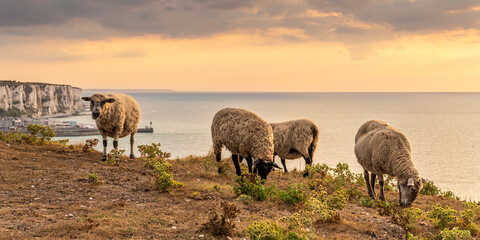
[233,173,278,201]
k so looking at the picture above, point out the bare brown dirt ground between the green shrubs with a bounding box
[0,141,478,239]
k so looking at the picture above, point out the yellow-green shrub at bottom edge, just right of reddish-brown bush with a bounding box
[246,220,285,240]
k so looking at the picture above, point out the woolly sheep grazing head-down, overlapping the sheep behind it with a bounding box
[211,108,281,179]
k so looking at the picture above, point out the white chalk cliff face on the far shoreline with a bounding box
[0,81,82,116]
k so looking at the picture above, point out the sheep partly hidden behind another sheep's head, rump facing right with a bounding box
[270,119,318,176]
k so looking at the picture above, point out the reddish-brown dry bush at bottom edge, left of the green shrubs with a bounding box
[202,202,240,236]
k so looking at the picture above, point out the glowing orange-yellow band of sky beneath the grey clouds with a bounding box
[0,1,480,92]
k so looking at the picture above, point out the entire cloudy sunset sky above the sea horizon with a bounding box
[0,0,480,92]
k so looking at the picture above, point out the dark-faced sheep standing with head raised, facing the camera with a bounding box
[82,93,140,162]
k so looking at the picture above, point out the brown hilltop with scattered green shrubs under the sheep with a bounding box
[0,127,480,239]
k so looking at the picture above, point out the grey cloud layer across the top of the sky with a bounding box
[0,0,480,41]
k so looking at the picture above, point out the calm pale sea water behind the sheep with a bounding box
[54,93,480,201]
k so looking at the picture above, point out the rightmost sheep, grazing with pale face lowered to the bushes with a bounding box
[355,120,423,206]
